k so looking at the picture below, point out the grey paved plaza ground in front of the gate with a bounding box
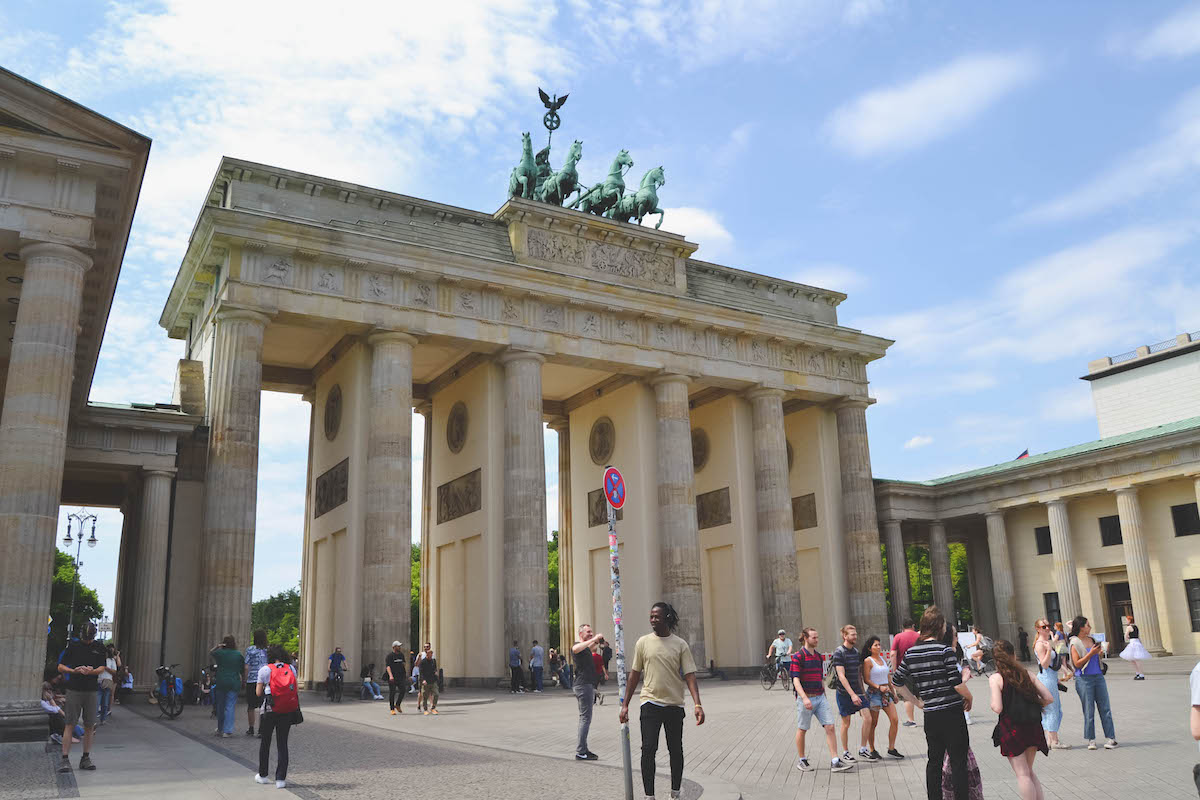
[0,657,1198,800]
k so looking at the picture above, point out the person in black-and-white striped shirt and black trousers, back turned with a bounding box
[893,606,971,800]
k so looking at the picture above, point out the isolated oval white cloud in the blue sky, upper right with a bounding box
[826,53,1038,158]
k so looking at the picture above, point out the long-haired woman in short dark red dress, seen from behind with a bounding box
[988,639,1058,800]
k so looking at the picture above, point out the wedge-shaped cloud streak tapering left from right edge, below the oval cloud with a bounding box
[1018,86,1200,222]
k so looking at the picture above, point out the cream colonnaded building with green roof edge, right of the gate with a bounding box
[875,331,1200,655]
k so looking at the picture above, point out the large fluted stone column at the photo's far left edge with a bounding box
[0,243,91,741]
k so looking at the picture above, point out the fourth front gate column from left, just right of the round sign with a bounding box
[652,374,705,669]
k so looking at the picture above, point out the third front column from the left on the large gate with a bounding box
[500,350,550,663]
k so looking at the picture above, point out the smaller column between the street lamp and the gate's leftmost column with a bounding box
[127,470,175,687]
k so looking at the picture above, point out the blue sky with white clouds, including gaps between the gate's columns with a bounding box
[9,0,1200,614]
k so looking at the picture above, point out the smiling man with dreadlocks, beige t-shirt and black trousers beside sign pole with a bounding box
[619,602,704,800]
